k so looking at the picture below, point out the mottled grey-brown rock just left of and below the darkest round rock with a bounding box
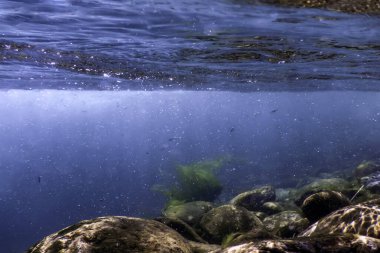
[263,211,309,238]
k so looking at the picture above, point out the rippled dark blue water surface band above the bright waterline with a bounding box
[0,0,380,91]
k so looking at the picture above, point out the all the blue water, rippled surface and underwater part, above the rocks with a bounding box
[0,0,380,252]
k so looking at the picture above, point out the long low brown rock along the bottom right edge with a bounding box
[210,234,380,253]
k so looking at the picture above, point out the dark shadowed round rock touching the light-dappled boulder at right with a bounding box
[301,191,350,223]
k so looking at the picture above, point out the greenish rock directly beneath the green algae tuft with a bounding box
[163,201,214,226]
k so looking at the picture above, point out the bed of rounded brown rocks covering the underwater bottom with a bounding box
[28,161,380,253]
